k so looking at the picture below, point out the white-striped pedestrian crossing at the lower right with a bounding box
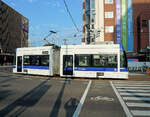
[110,81,150,117]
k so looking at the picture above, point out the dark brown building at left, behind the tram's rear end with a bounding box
[0,0,29,65]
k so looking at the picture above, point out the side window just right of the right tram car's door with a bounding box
[75,54,91,67]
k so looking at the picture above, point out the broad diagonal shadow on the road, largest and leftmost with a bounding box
[0,80,51,117]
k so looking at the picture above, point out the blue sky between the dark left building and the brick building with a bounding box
[2,0,82,46]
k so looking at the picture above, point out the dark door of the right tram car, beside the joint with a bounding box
[63,55,73,75]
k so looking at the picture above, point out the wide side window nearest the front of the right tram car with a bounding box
[93,54,117,67]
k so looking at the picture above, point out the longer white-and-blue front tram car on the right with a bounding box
[60,44,128,79]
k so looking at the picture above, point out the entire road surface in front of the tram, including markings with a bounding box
[0,72,150,117]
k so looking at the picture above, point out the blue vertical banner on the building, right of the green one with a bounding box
[127,0,133,51]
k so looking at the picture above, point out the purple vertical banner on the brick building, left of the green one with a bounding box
[116,0,121,44]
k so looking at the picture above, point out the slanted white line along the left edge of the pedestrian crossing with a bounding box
[110,81,133,117]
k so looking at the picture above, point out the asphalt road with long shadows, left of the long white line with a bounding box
[0,73,88,117]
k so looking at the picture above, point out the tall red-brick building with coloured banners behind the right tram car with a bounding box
[82,0,150,52]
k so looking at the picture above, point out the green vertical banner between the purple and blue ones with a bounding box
[121,0,127,51]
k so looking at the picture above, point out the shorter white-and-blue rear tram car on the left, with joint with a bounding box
[13,46,60,76]
